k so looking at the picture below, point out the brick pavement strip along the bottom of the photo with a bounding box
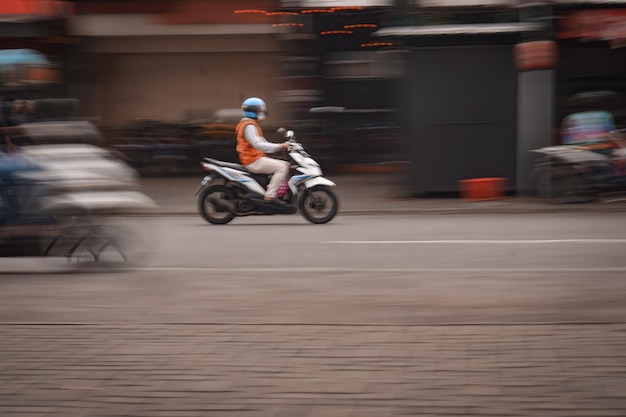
[0,323,626,417]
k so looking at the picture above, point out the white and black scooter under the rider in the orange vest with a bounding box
[194,128,339,224]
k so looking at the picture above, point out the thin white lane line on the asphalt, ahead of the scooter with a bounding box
[320,239,626,245]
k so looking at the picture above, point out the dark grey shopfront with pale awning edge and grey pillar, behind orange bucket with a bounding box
[368,2,556,194]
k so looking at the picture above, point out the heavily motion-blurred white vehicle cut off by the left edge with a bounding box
[0,122,156,265]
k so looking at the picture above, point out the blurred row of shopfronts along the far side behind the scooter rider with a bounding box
[0,0,626,193]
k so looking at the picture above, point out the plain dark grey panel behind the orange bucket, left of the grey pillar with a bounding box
[400,45,517,193]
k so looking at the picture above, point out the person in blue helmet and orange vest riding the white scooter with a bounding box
[235,97,289,205]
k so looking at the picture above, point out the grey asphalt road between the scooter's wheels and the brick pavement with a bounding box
[0,213,626,324]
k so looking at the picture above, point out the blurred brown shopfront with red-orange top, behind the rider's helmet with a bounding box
[70,0,281,127]
